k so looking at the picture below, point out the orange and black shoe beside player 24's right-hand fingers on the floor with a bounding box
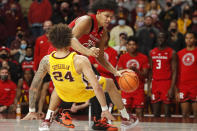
[92,117,118,131]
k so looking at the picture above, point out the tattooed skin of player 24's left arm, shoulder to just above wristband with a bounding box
[29,56,49,108]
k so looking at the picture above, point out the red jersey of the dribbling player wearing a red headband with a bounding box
[48,14,103,54]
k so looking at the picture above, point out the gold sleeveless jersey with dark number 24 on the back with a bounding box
[49,52,106,102]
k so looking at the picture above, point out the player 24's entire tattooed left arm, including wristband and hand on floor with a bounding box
[23,55,49,120]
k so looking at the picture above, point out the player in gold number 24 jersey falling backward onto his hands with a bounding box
[24,24,134,130]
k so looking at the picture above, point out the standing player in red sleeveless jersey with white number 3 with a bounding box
[148,32,177,117]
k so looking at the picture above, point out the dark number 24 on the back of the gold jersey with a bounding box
[53,71,74,82]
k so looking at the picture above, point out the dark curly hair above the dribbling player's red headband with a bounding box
[90,0,118,14]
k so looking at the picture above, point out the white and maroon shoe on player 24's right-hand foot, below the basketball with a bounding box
[121,115,139,129]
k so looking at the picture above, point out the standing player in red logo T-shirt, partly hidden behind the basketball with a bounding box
[118,36,149,117]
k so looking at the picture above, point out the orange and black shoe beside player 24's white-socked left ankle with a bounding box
[55,110,75,128]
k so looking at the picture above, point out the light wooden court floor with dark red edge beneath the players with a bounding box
[0,114,197,131]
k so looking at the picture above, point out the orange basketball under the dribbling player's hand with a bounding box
[118,72,139,92]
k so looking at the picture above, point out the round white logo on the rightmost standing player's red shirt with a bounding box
[182,53,195,66]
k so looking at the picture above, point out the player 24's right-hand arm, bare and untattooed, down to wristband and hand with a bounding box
[74,55,115,120]
